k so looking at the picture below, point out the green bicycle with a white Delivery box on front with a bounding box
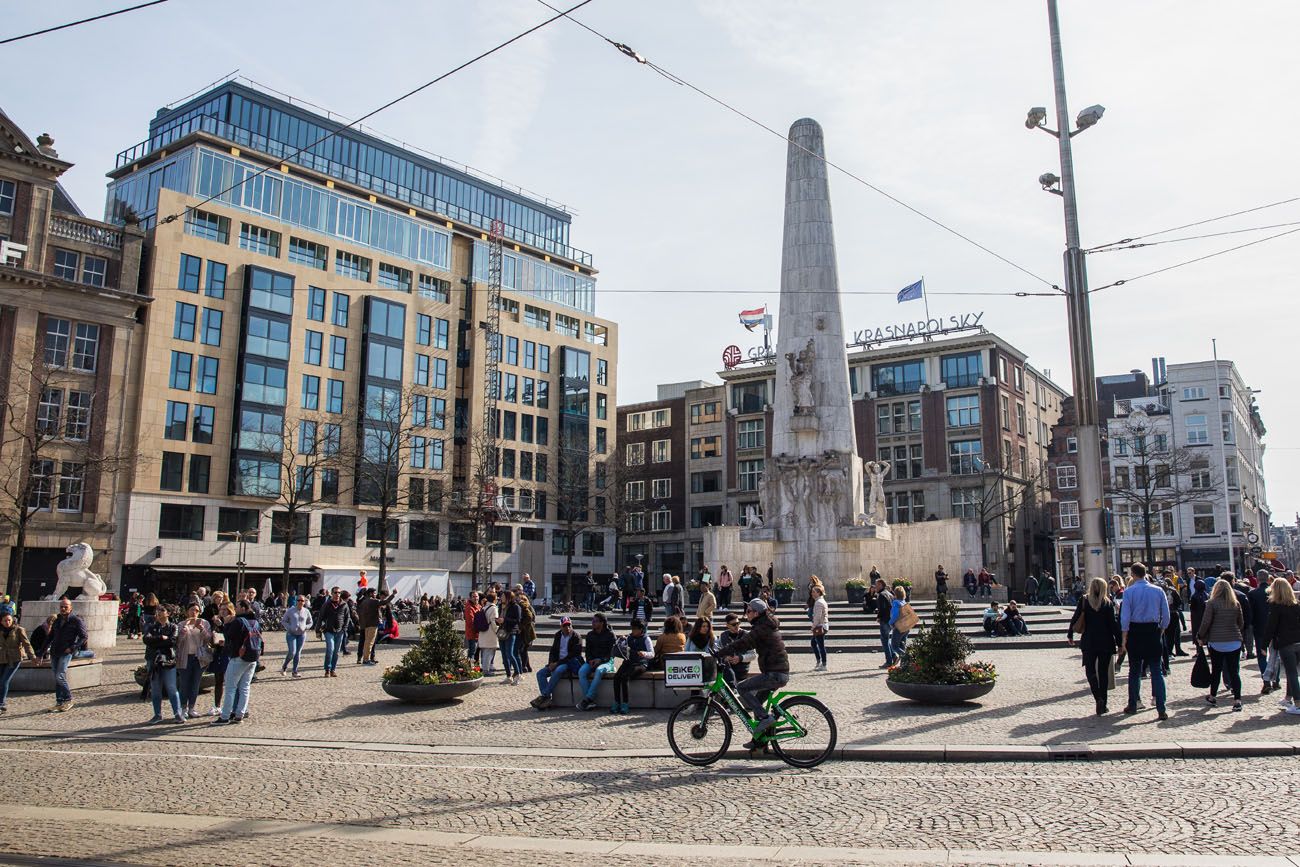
[664,654,836,768]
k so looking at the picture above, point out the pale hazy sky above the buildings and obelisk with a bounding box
[0,0,1300,523]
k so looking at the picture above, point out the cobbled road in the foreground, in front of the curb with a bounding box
[0,737,1300,866]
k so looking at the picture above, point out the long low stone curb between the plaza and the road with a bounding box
[0,728,1300,763]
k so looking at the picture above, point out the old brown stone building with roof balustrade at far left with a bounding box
[0,112,150,599]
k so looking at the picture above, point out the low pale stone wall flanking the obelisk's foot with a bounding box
[705,519,980,599]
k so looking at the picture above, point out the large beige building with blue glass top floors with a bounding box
[98,82,618,594]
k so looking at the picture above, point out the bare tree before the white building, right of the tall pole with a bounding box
[1106,409,1222,563]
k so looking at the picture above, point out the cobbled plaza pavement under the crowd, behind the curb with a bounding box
[0,637,1300,750]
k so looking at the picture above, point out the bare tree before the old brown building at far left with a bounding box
[0,363,137,599]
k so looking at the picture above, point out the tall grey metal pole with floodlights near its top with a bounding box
[1024,0,1106,587]
